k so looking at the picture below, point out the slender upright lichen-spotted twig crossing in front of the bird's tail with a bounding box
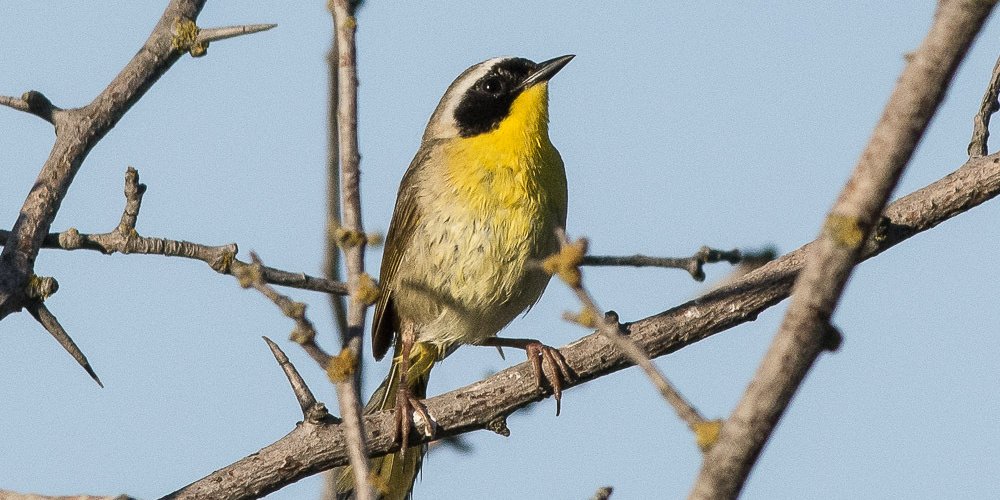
[327,0,375,500]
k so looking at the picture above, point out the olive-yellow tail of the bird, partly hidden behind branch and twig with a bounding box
[333,342,439,500]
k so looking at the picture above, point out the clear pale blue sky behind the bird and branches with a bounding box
[0,0,1000,499]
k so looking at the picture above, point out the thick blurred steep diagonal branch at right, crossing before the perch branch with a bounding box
[690,0,993,499]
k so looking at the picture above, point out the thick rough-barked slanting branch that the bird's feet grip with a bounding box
[167,149,1000,499]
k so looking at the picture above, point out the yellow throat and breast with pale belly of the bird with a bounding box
[400,85,566,345]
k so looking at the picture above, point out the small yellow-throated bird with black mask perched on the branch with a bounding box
[335,55,574,500]
